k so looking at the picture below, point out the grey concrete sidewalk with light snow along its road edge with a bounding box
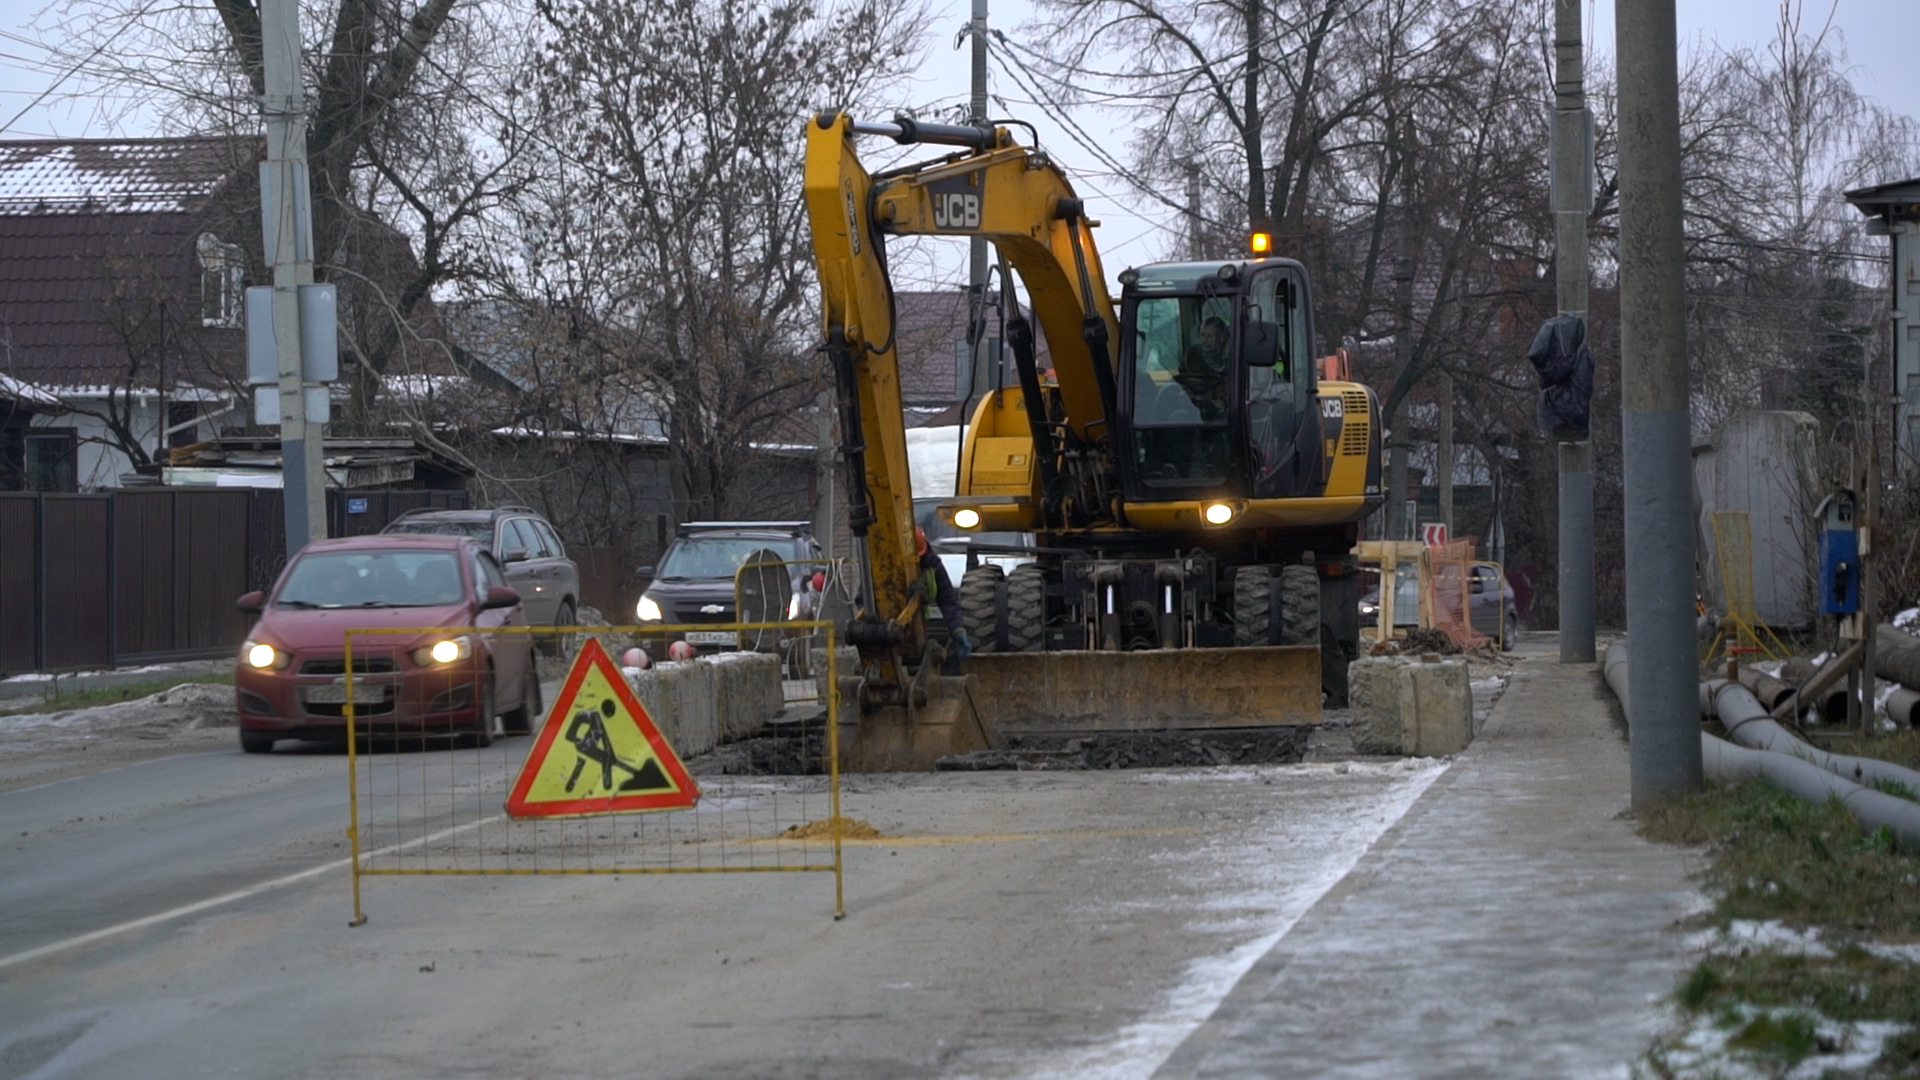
[1156,645,1703,1078]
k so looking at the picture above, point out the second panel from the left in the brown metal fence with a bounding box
[40,496,113,671]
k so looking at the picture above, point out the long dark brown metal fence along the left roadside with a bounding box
[0,488,468,675]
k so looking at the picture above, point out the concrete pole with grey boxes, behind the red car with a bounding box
[259,0,326,545]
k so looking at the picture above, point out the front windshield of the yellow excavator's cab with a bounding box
[1133,296,1238,484]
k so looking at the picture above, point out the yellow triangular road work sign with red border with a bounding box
[507,638,701,817]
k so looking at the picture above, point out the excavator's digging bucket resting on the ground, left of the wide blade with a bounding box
[841,675,993,773]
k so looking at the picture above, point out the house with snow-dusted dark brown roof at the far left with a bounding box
[0,136,265,492]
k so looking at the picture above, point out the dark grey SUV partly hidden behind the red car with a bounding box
[382,505,580,653]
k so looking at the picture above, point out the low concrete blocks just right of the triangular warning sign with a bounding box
[624,653,783,757]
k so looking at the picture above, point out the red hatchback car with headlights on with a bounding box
[234,536,541,753]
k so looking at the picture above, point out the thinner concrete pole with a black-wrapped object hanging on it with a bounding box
[1553,0,1594,663]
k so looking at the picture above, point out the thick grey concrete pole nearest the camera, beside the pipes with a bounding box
[1613,0,1701,809]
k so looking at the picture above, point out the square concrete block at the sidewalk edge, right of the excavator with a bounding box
[1348,657,1473,757]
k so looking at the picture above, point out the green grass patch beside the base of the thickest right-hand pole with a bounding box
[1640,780,1920,940]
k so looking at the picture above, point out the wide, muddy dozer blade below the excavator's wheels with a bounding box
[964,646,1321,742]
